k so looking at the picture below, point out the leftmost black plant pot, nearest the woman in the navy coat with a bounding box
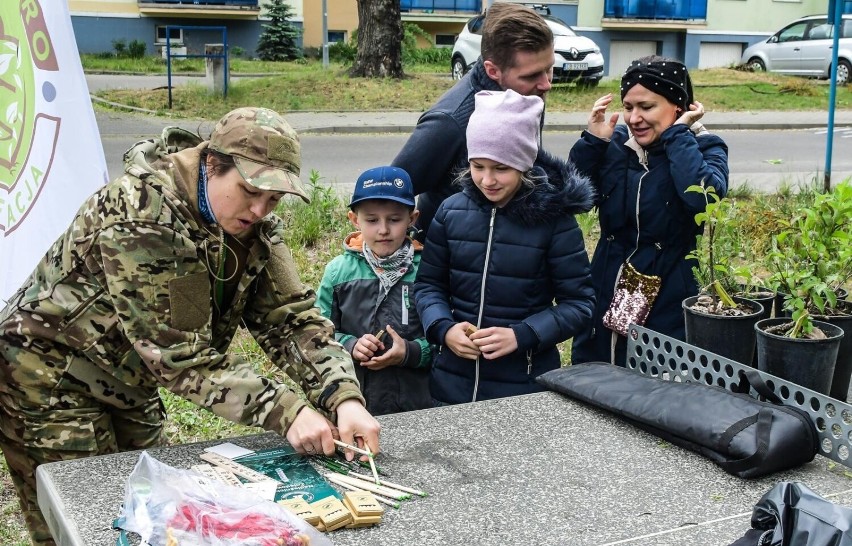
[682,296,763,366]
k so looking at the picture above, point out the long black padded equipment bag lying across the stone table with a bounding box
[537,363,819,478]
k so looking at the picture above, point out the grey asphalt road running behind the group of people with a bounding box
[97,111,852,196]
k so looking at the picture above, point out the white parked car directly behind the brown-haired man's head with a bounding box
[451,14,604,87]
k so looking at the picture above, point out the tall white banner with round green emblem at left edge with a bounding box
[0,0,108,298]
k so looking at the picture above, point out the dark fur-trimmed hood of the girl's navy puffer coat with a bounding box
[457,149,595,225]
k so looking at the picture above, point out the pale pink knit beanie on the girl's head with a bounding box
[467,89,544,172]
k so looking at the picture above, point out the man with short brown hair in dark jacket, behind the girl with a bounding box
[392,3,554,241]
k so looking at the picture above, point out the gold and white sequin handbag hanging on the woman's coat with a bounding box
[603,261,663,336]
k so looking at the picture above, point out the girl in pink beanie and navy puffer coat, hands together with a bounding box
[414,90,594,405]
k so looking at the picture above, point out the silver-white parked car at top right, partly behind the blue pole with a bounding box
[741,14,852,85]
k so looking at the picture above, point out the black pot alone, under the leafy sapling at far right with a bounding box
[754,317,843,396]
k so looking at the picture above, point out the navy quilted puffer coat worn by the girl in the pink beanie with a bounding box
[414,152,594,404]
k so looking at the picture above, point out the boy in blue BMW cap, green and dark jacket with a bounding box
[317,167,433,415]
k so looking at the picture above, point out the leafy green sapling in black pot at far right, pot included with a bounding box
[755,181,852,400]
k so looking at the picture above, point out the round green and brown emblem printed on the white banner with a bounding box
[0,0,59,233]
